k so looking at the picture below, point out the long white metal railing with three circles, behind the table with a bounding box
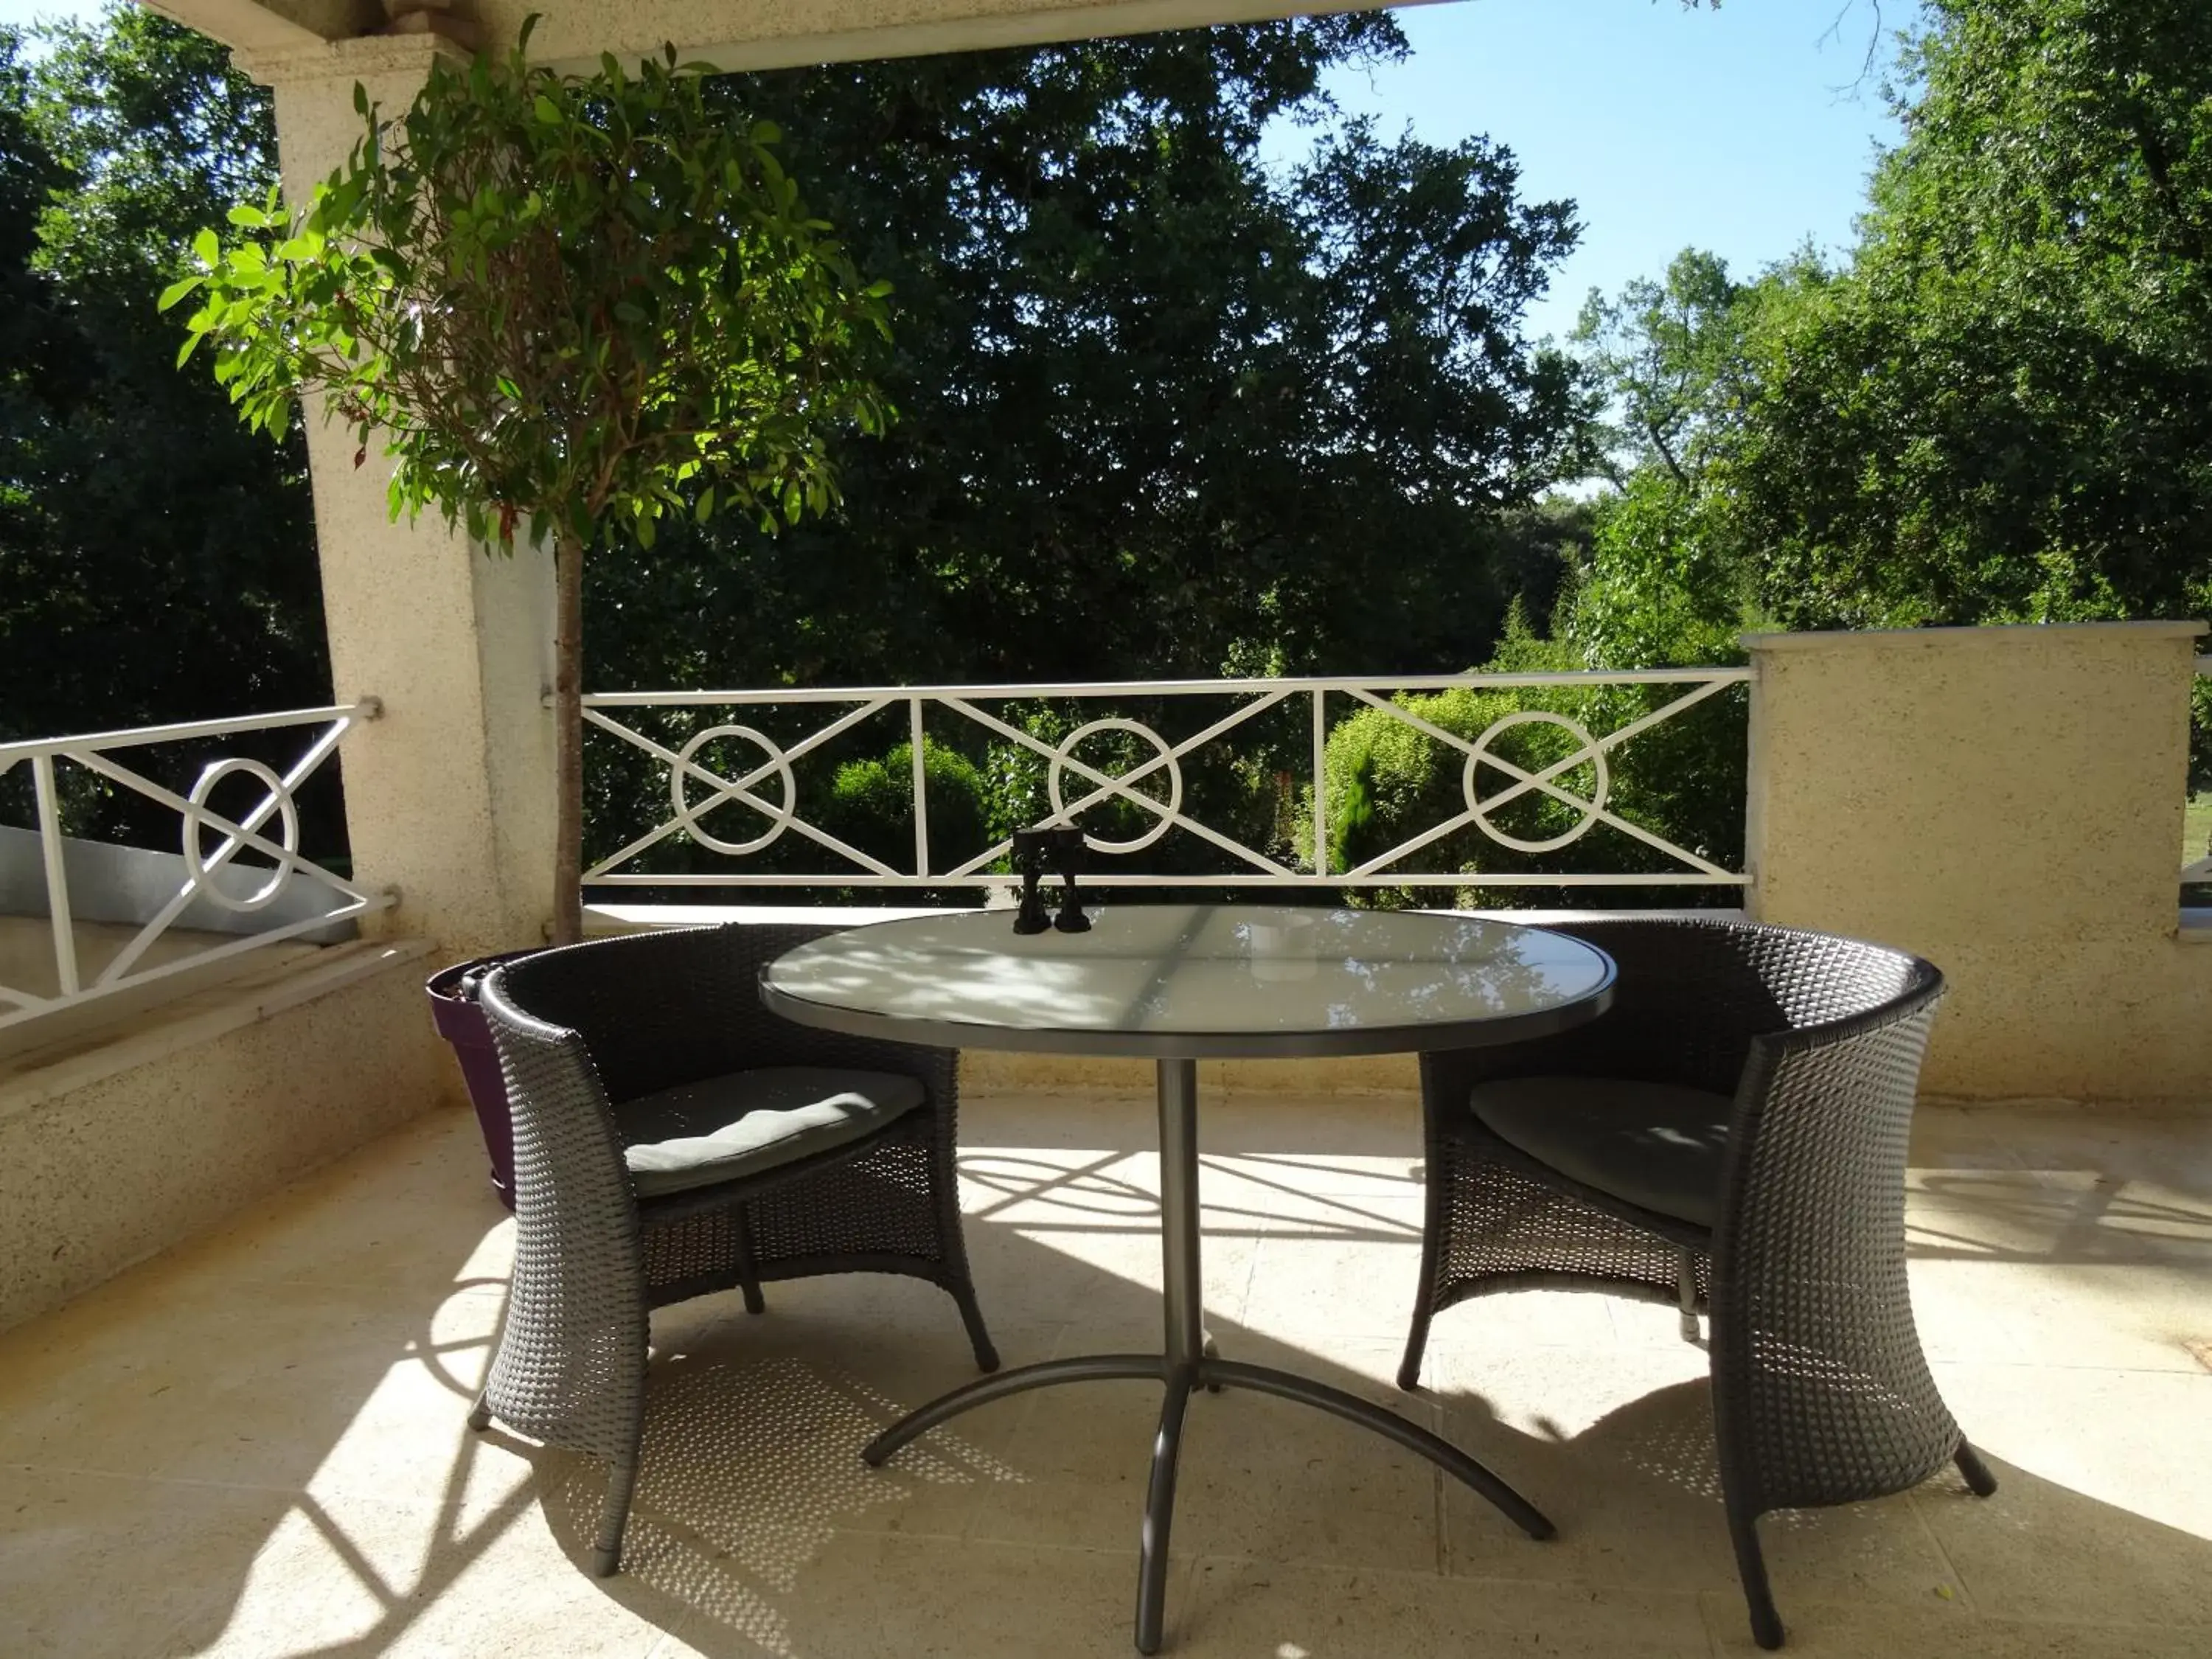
[584,668,1752,889]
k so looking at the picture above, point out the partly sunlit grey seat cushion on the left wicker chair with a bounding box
[615,1066,927,1199]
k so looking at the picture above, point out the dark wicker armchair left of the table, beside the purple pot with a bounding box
[469,925,998,1575]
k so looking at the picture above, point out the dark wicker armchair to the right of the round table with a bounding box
[1398,922,1995,1648]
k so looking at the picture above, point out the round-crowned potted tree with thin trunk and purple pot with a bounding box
[161,18,889,1194]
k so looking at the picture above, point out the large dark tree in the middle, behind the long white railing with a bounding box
[593,27,1579,703]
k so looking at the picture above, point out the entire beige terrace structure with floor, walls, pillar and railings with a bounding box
[0,0,2212,1659]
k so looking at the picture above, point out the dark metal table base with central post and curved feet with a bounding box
[860,1060,1553,1652]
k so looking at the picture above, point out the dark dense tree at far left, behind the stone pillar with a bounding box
[0,7,330,734]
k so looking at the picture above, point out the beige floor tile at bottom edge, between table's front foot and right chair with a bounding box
[1168,1559,1710,1659]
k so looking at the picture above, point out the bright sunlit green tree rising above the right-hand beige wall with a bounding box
[1562,0,2212,787]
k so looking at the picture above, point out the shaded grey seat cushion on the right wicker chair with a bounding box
[1469,1077,1734,1228]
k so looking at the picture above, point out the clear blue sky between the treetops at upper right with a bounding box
[0,0,1907,336]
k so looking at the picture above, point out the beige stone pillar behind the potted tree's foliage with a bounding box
[237,35,555,958]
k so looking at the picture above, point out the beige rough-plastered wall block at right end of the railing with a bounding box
[1745,622,2212,1104]
